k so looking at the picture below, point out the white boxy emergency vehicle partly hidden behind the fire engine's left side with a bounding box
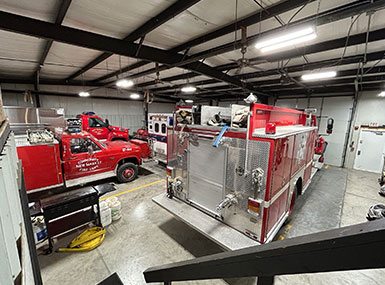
[148,113,174,163]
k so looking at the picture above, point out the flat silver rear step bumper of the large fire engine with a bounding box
[152,194,260,250]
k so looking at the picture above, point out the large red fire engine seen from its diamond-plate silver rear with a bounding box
[153,103,317,249]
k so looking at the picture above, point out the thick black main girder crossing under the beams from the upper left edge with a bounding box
[0,11,266,95]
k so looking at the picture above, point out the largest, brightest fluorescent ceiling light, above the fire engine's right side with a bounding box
[255,27,317,52]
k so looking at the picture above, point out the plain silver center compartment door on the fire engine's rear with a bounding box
[188,140,226,215]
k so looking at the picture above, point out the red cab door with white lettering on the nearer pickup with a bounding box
[64,137,112,180]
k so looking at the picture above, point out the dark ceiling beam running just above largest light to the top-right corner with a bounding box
[118,0,385,85]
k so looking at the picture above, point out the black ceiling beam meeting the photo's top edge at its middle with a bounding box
[67,0,200,80]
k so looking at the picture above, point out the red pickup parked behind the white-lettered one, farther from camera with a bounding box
[76,112,129,141]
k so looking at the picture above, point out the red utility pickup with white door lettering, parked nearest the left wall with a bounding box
[15,132,143,192]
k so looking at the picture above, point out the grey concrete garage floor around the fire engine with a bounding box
[39,166,385,285]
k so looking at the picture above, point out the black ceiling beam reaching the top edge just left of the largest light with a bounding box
[95,0,315,81]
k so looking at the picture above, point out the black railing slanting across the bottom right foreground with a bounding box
[144,219,385,285]
